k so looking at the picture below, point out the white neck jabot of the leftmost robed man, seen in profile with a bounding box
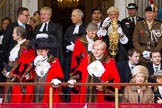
[9,39,26,61]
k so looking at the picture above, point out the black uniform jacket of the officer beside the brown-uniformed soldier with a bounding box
[121,16,144,50]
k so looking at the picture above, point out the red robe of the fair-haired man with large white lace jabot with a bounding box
[71,57,120,103]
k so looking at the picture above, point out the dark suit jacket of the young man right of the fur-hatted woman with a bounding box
[147,63,162,83]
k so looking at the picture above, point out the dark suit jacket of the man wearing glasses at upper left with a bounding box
[2,21,33,52]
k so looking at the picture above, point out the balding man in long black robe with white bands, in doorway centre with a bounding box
[64,9,86,102]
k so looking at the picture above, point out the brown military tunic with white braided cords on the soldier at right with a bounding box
[133,20,162,64]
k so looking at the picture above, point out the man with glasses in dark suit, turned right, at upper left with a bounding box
[2,7,32,53]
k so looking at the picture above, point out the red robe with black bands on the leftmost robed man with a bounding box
[11,49,36,103]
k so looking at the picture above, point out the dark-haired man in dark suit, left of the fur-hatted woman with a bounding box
[117,48,140,92]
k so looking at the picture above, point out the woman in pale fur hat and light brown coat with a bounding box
[122,65,154,103]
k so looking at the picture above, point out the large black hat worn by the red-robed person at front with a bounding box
[34,35,58,49]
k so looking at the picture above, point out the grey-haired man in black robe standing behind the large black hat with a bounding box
[33,7,63,65]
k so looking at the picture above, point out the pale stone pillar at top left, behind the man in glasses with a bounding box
[22,0,38,16]
